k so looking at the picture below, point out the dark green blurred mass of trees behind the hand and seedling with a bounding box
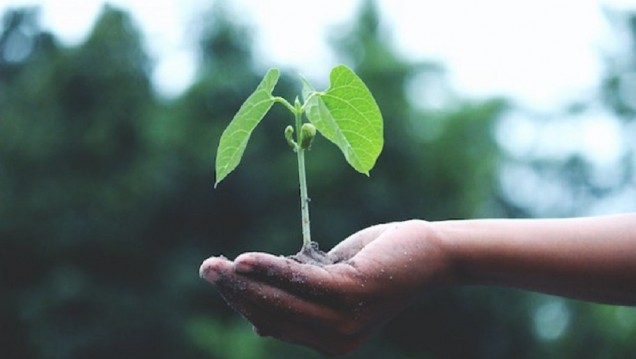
[0,1,636,358]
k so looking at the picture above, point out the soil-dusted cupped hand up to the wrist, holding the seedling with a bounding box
[200,220,450,354]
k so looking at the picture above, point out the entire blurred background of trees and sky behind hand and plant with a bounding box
[0,0,636,359]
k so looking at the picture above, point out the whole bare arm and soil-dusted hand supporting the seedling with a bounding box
[200,214,636,354]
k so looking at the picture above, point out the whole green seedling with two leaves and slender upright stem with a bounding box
[214,65,384,250]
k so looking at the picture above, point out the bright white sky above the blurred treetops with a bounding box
[0,0,636,108]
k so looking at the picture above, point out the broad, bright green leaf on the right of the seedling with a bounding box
[303,65,384,176]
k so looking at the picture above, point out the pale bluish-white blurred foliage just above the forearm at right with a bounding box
[501,9,636,217]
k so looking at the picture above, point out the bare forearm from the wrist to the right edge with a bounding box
[432,214,636,305]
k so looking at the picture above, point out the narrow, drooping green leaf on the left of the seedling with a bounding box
[214,69,279,187]
